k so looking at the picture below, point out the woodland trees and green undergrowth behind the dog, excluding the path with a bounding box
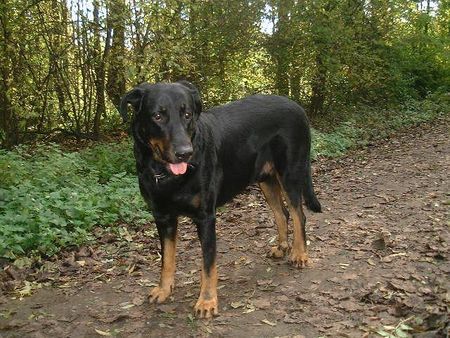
[0,0,450,263]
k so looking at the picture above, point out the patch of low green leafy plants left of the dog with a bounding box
[0,143,152,257]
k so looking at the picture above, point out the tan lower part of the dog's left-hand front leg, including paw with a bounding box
[150,239,176,303]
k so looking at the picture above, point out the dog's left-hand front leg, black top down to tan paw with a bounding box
[150,216,177,303]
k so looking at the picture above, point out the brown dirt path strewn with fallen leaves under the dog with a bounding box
[0,120,450,337]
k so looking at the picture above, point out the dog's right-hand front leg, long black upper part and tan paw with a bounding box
[194,215,219,318]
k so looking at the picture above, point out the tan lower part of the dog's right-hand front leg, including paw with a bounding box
[194,262,219,318]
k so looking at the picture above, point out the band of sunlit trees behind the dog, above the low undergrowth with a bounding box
[0,0,450,148]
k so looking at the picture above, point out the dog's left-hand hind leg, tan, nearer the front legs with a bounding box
[259,176,289,258]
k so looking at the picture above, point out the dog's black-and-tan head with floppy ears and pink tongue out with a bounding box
[120,81,202,175]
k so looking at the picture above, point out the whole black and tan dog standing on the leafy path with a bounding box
[121,81,321,318]
